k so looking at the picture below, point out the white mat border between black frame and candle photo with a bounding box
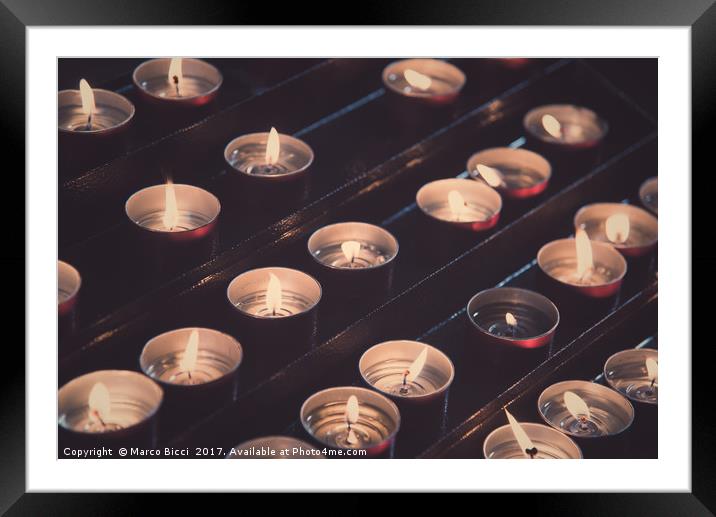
[27,27,691,491]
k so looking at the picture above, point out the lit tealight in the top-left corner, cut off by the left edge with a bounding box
[57,79,134,135]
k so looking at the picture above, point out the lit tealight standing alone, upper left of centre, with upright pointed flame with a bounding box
[224,127,313,182]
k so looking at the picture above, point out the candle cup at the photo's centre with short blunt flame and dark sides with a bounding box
[308,222,398,298]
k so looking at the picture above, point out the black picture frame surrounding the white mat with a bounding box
[0,0,716,515]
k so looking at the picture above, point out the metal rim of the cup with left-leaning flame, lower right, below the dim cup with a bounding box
[537,380,634,439]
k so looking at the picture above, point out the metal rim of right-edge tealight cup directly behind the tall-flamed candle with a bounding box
[574,203,659,257]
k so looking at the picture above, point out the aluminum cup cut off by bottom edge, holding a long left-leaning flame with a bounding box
[482,422,582,460]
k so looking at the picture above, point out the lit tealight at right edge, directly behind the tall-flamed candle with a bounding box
[574,203,659,257]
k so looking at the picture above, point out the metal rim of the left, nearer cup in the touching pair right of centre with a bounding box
[415,178,502,232]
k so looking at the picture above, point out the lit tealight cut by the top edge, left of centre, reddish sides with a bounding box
[132,57,223,106]
